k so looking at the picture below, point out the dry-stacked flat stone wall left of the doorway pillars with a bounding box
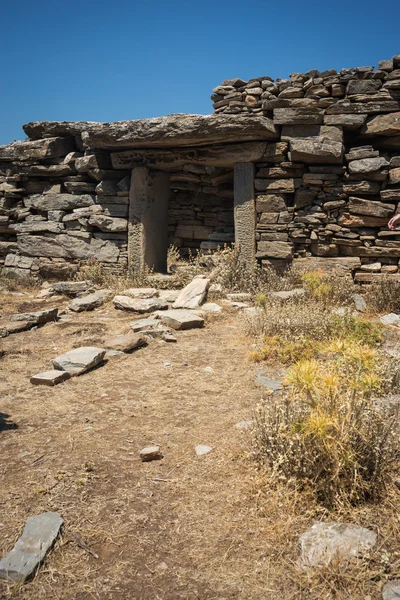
[0,136,129,278]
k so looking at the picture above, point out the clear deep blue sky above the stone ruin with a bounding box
[0,0,400,144]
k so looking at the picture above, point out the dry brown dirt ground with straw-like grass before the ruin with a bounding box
[0,288,400,600]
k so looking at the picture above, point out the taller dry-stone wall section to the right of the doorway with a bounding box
[212,56,400,281]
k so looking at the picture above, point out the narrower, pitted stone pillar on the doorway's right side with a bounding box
[233,163,256,263]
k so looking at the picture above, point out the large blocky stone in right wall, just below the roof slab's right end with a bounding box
[290,137,344,164]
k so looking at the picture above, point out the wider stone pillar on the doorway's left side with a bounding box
[128,167,170,273]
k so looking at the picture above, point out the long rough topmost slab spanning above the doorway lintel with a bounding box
[24,114,278,149]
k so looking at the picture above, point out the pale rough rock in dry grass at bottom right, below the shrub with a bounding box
[299,522,377,568]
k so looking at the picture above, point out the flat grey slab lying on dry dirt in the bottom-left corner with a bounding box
[0,512,63,583]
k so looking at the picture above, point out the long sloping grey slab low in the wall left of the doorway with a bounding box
[17,234,119,263]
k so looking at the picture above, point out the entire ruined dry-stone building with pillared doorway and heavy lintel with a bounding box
[0,55,400,282]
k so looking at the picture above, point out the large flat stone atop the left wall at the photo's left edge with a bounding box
[0,137,73,161]
